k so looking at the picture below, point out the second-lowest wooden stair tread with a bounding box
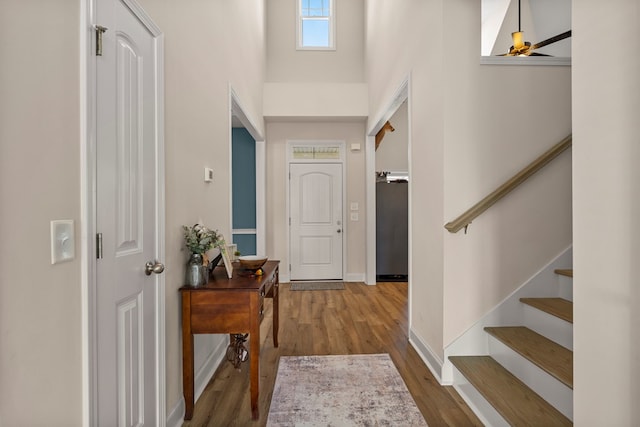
[484,326,573,389]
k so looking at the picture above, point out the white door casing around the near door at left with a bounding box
[80,0,167,427]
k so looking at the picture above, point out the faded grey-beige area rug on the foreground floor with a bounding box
[267,354,427,427]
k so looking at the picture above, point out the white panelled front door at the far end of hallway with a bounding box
[289,163,343,280]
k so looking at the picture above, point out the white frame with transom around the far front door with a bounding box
[280,139,344,282]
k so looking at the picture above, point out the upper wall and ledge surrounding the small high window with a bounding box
[264,0,368,121]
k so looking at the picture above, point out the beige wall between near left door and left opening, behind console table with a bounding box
[134,0,265,411]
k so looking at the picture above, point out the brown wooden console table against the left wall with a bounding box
[180,261,280,420]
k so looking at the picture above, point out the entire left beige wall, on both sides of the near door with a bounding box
[0,0,265,426]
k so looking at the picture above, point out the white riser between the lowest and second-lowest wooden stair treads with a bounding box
[487,334,573,420]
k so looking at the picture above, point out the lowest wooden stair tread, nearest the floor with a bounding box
[449,356,573,427]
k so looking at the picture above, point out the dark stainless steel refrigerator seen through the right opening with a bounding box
[376,172,409,282]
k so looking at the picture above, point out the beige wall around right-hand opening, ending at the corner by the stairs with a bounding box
[366,0,444,357]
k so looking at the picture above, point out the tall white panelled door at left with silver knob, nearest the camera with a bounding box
[94,0,163,426]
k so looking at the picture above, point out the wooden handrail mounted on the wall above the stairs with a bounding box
[444,135,573,233]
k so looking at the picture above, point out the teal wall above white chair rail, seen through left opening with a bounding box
[231,128,256,229]
